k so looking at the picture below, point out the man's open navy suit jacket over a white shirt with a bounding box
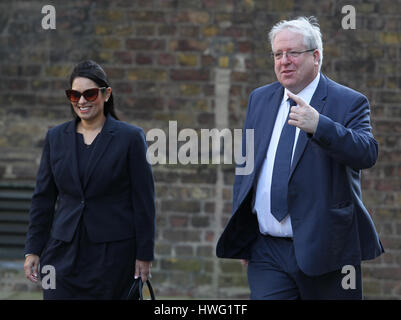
[216,74,384,275]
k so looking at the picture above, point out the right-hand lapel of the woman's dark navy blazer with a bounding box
[83,115,114,190]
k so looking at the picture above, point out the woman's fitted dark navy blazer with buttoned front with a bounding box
[25,115,155,261]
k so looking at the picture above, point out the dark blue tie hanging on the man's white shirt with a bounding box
[270,98,297,221]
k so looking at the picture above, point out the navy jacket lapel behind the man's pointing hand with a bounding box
[288,74,327,181]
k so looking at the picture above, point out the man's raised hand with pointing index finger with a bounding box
[287,91,319,134]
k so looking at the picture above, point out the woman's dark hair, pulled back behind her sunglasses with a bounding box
[70,60,120,120]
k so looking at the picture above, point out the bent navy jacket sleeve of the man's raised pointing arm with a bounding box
[312,95,378,170]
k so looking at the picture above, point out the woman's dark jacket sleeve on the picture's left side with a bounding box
[24,132,58,256]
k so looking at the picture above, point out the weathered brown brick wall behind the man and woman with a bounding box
[0,0,401,299]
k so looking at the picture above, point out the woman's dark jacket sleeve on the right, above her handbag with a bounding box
[129,129,156,261]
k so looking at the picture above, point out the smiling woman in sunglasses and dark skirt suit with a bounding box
[24,61,155,299]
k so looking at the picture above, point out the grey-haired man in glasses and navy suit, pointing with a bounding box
[217,17,384,299]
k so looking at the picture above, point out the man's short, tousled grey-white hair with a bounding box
[269,16,323,71]
